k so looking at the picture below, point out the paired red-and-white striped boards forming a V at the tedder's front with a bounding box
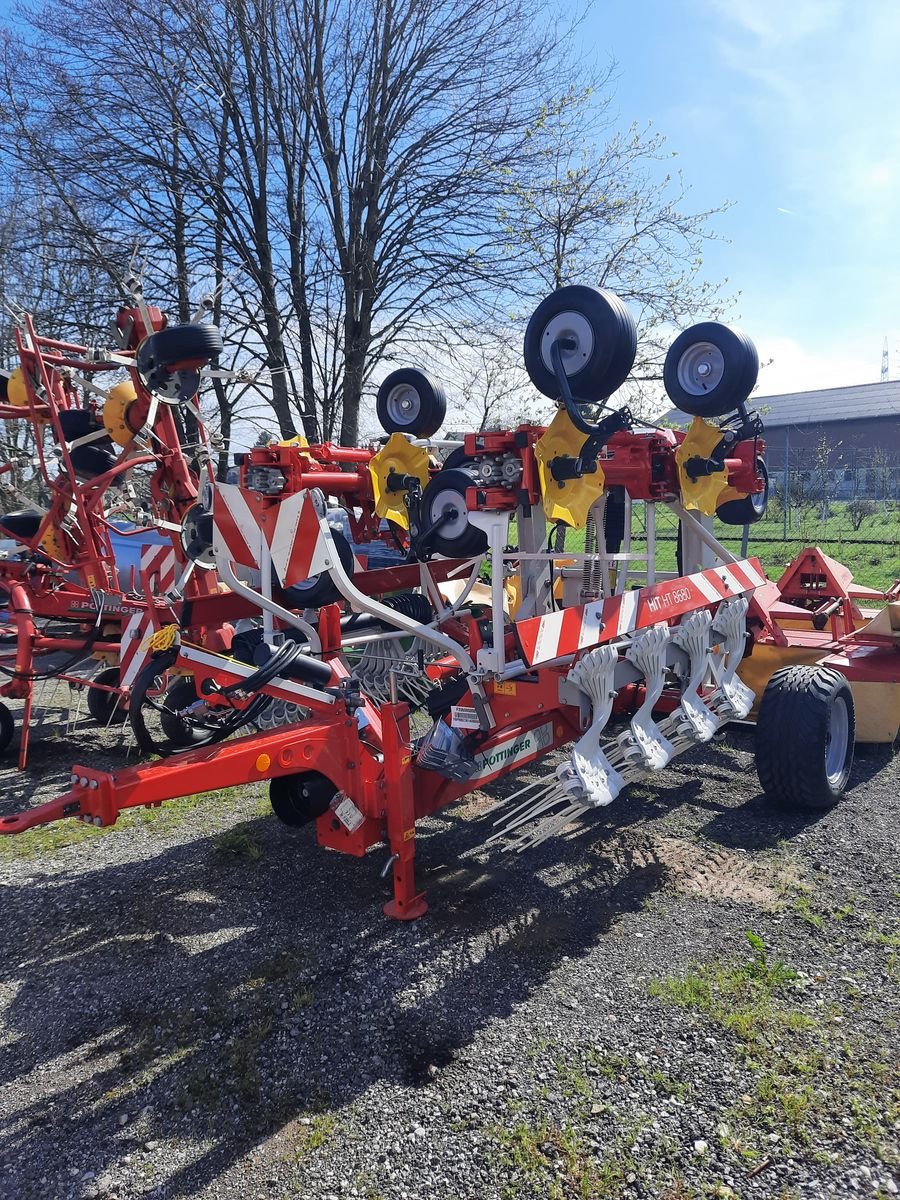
[212,484,331,587]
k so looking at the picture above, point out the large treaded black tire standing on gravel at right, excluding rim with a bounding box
[756,665,856,812]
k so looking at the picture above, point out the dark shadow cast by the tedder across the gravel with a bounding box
[0,772,665,1198]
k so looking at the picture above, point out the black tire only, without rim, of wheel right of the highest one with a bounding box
[662,320,760,418]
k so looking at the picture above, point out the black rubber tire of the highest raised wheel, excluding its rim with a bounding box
[524,284,637,402]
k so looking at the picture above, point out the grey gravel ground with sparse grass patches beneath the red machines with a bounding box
[0,696,900,1200]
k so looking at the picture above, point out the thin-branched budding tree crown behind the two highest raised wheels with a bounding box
[503,87,727,408]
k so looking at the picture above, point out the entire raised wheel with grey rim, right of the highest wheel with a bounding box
[662,320,760,418]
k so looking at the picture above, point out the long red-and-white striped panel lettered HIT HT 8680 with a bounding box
[516,558,766,666]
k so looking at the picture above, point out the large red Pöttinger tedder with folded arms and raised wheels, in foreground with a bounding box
[0,287,900,919]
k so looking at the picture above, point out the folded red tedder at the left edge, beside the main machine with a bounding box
[0,289,236,767]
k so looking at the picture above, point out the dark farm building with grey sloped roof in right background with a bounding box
[667,380,900,500]
